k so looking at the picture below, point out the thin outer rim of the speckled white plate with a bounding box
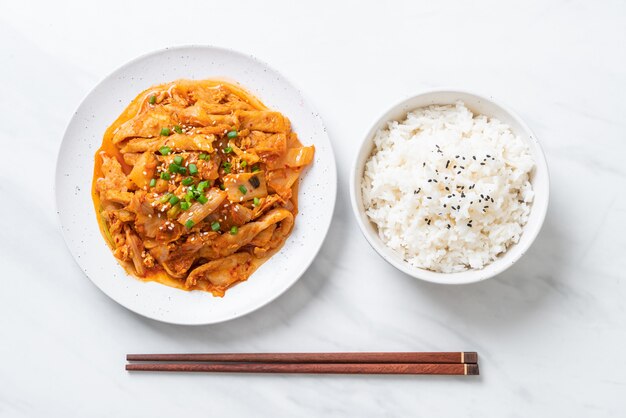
[52,44,338,326]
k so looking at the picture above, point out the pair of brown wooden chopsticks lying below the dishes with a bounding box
[126,352,479,376]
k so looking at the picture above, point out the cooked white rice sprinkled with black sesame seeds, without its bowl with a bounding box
[362,102,534,273]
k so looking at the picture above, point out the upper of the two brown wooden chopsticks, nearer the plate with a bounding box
[126,351,478,364]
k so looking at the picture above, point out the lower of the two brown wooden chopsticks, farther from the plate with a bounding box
[126,363,479,376]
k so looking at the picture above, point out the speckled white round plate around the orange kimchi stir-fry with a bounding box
[55,46,337,325]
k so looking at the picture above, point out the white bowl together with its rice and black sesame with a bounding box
[350,90,549,284]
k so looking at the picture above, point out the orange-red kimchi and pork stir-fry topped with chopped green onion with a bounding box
[93,80,314,296]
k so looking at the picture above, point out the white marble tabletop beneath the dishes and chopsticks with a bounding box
[0,0,626,417]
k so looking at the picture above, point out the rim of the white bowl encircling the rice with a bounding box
[350,87,550,285]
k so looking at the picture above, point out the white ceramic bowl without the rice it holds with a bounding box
[350,90,550,284]
